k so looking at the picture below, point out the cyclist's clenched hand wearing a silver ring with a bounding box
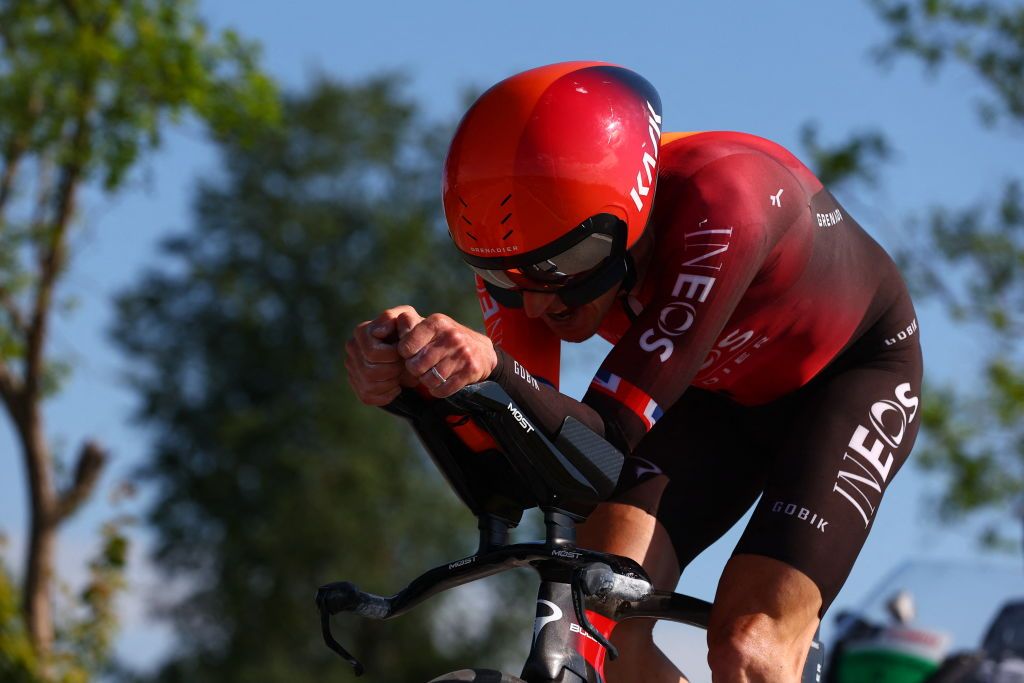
[398,313,498,398]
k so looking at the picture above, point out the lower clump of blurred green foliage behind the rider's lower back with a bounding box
[904,179,1024,545]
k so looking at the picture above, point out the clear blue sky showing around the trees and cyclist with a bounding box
[0,0,1021,680]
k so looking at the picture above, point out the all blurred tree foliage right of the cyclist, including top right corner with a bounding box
[812,0,1024,545]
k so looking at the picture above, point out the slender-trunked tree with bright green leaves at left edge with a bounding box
[0,0,276,681]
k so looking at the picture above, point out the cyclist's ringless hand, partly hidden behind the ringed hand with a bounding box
[345,306,423,405]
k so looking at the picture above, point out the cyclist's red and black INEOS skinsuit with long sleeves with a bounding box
[477,132,922,613]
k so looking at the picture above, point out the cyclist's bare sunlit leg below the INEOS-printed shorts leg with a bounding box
[708,555,821,683]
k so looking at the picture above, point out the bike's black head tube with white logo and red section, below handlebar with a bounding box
[522,581,615,683]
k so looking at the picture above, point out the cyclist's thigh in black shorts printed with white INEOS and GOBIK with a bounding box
[735,329,922,614]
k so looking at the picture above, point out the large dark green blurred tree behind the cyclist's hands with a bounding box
[116,79,530,683]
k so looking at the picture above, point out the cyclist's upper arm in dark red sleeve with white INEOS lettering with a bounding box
[584,154,804,450]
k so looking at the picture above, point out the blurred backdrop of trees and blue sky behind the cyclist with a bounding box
[0,0,1024,682]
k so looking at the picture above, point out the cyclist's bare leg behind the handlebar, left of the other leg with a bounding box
[579,499,686,683]
